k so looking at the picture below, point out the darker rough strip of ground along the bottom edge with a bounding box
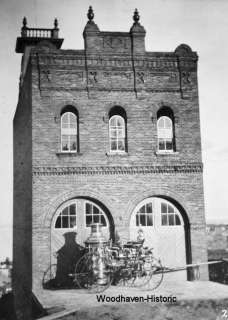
[71,300,228,320]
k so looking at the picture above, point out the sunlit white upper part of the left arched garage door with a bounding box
[51,198,111,264]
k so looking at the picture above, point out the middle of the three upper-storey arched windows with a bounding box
[109,115,126,152]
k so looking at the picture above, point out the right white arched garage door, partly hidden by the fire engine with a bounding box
[130,197,187,280]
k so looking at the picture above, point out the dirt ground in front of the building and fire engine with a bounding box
[39,281,228,320]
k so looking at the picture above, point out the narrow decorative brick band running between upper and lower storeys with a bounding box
[33,163,203,176]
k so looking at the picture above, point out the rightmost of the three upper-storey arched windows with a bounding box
[157,116,174,151]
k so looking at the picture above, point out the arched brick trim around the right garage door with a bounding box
[126,188,192,280]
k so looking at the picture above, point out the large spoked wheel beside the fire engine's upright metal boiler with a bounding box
[74,252,112,293]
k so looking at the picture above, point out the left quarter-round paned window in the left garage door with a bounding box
[55,203,76,229]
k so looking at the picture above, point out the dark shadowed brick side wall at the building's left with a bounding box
[12,62,32,320]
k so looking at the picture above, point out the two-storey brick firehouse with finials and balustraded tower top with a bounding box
[13,8,207,319]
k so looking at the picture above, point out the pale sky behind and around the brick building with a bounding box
[0,0,228,259]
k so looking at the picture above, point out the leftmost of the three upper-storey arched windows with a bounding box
[61,111,78,152]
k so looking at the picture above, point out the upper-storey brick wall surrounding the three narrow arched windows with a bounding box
[33,90,201,166]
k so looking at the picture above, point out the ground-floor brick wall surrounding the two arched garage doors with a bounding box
[33,174,207,290]
